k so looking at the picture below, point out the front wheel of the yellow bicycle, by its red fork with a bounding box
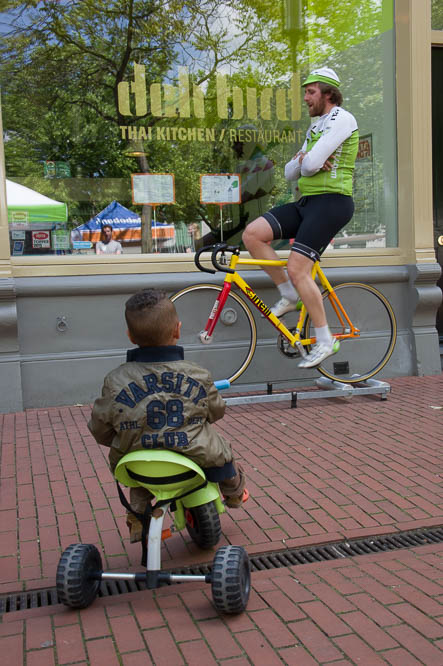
[171,284,257,383]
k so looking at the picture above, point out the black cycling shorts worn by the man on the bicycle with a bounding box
[263,193,354,261]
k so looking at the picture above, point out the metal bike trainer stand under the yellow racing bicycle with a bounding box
[224,377,391,409]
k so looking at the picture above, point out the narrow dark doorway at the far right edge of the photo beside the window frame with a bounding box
[432,47,443,343]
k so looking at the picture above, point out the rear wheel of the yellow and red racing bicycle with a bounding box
[306,282,397,384]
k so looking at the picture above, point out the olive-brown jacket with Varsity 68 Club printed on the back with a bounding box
[88,346,232,470]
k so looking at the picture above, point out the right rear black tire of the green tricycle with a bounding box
[211,546,251,614]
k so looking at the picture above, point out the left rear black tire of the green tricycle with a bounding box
[56,543,103,608]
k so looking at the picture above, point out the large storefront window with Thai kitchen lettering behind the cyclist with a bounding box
[0,0,397,256]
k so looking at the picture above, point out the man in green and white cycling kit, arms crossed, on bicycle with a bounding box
[243,67,359,368]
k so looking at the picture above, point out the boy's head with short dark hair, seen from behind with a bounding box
[125,289,178,347]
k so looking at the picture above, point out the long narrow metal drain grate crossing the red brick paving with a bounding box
[0,527,443,615]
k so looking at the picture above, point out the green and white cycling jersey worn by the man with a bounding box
[285,106,358,196]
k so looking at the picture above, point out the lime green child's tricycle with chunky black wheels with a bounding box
[56,382,251,614]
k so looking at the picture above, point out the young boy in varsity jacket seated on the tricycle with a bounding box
[88,289,247,543]
